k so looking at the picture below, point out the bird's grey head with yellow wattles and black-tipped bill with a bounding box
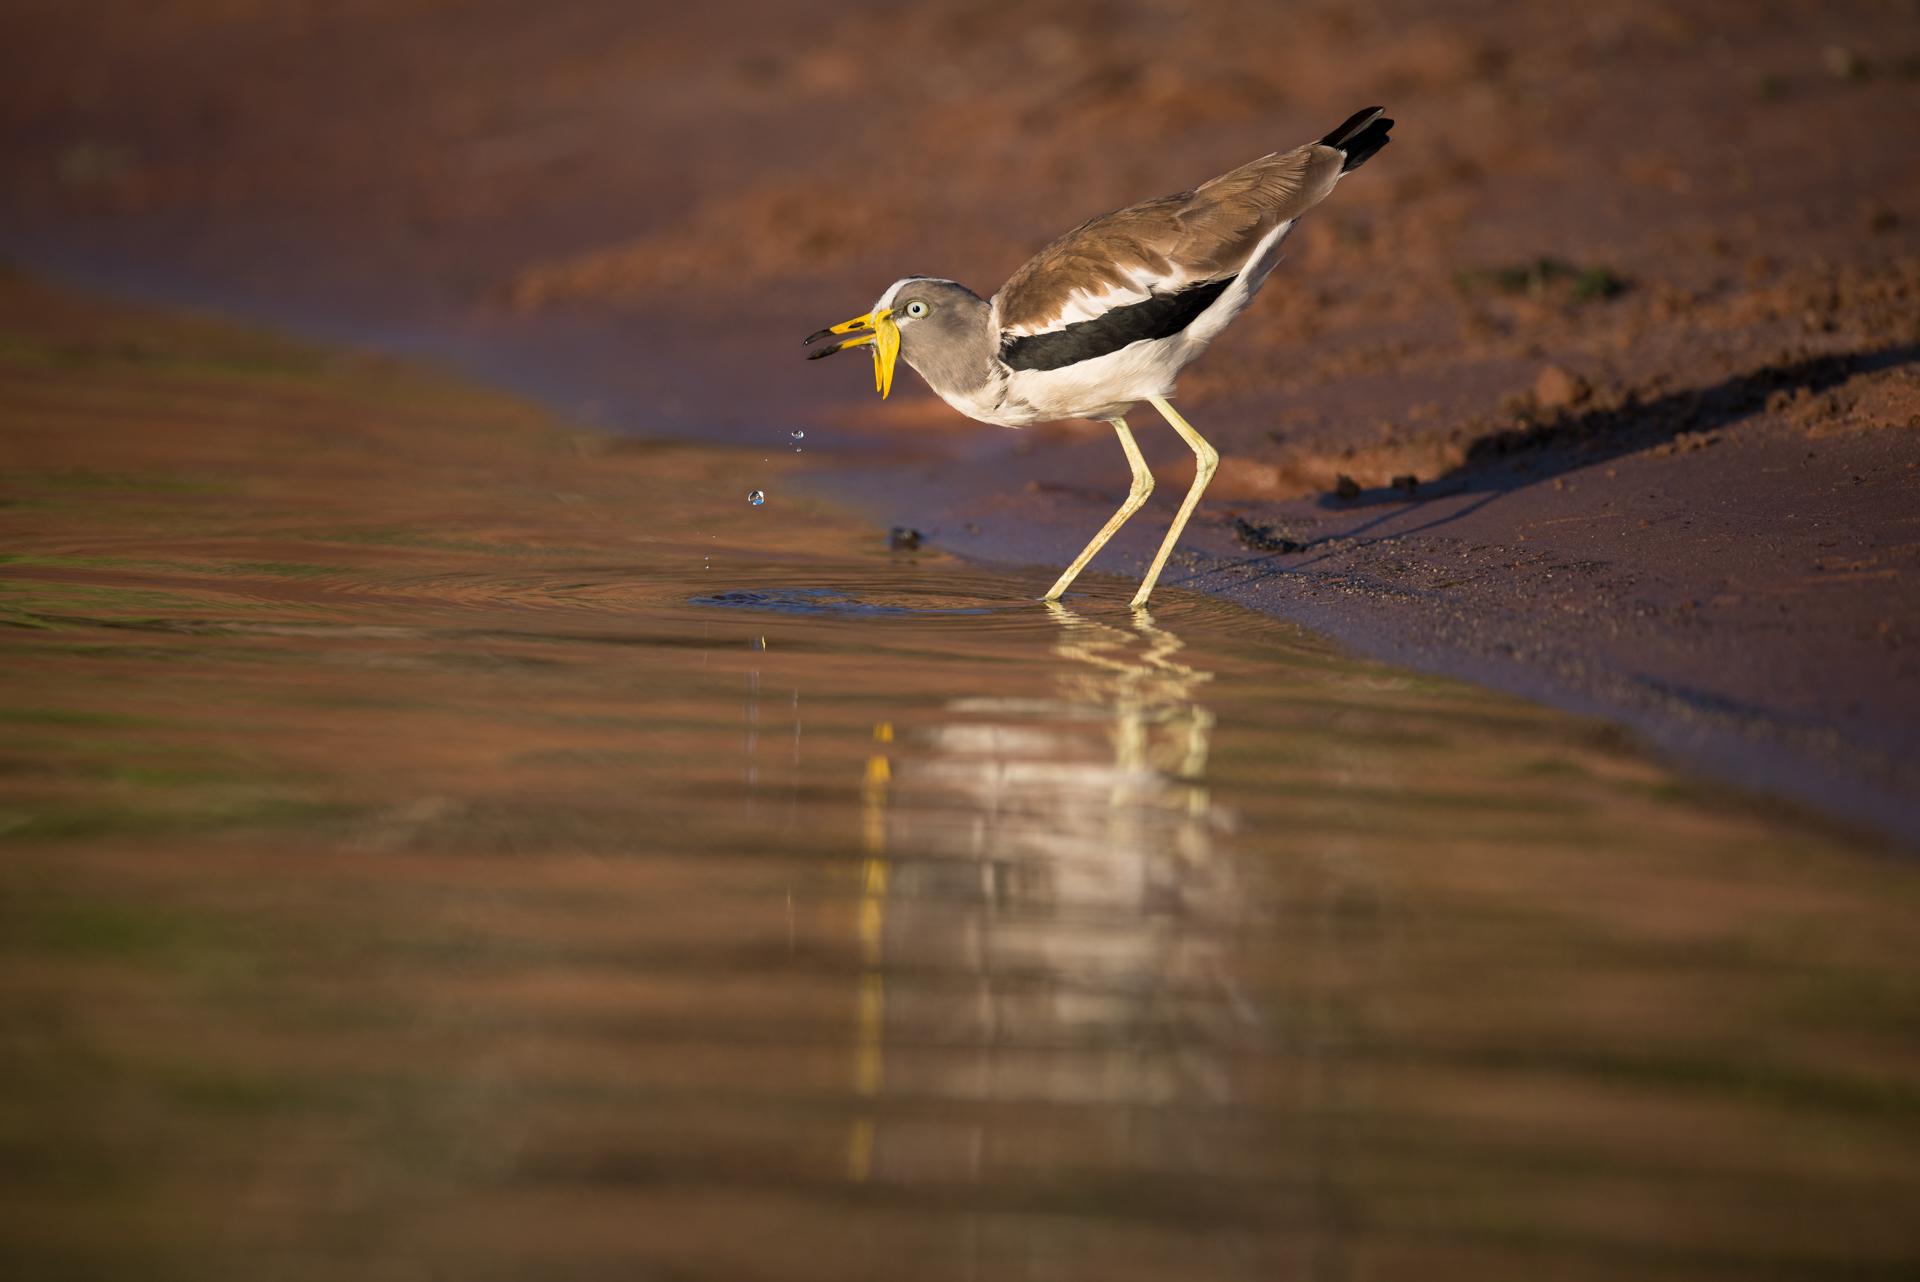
[806,276,998,397]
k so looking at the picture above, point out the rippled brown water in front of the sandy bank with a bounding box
[0,276,1920,1280]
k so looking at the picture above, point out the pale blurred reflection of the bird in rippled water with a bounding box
[849,605,1260,1184]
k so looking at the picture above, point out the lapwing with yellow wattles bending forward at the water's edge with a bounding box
[806,107,1394,610]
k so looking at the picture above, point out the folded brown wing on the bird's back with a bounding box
[995,142,1344,334]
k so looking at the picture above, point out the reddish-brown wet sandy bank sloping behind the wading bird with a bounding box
[0,0,1920,839]
